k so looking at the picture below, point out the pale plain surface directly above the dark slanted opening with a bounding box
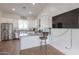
[48,3,79,16]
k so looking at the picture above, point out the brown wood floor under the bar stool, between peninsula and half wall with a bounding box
[20,45,64,55]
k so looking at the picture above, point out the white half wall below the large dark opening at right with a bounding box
[50,29,79,55]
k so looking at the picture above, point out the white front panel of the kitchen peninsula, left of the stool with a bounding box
[20,36,40,50]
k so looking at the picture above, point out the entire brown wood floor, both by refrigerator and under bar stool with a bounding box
[0,40,64,55]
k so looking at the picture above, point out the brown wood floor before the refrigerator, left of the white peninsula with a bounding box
[0,40,20,55]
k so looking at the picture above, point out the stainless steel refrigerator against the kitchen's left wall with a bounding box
[1,23,13,41]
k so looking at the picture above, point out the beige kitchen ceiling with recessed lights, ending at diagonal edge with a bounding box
[0,3,47,17]
